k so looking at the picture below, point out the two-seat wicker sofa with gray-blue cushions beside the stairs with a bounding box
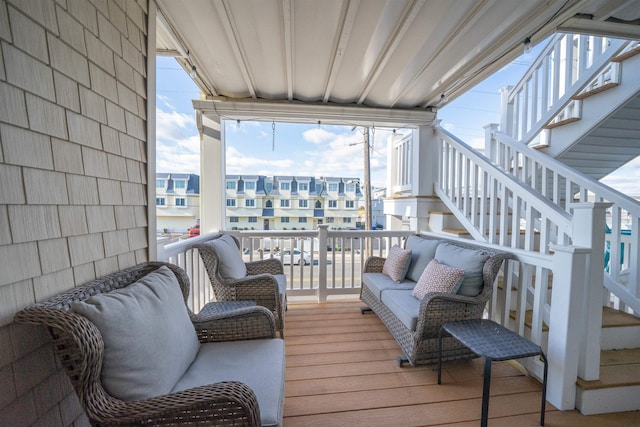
[360,235,511,366]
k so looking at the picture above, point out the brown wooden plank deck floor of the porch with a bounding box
[284,300,640,427]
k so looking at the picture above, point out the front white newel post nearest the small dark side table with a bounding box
[547,245,591,410]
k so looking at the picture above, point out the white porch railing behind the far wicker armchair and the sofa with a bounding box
[158,229,415,312]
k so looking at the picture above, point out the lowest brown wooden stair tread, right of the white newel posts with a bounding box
[577,349,640,390]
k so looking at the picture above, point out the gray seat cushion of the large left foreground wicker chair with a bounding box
[171,339,285,426]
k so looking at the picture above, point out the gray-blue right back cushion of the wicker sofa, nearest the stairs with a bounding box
[436,243,489,297]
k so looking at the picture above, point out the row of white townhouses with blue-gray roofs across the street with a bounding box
[156,173,363,232]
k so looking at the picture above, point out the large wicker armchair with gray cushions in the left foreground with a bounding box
[15,262,285,426]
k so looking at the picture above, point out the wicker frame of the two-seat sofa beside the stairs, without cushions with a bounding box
[360,236,513,366]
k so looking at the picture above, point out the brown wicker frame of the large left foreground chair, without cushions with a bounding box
[15,262,275,426]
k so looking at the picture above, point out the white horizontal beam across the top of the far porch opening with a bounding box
[192,97,435,128]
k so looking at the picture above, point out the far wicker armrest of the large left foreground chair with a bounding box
[191,306,276,343]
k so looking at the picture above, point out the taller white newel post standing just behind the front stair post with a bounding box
[570,203,612,381]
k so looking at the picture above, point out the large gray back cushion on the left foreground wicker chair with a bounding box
[71,266,200,401]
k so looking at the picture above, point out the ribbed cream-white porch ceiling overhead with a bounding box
[156,0,640,125]
